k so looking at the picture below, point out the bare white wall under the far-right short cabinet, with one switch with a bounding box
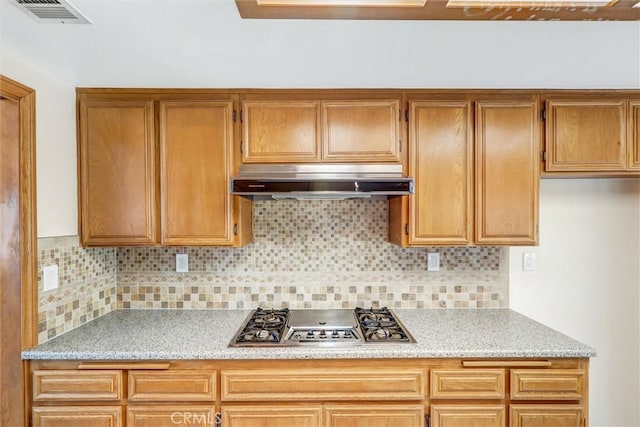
[509,179,640,427]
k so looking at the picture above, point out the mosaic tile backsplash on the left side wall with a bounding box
[38,236,117,343]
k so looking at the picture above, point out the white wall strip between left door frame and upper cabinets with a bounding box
[0,48,78,241]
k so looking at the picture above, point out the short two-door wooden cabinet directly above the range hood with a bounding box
[241,94,401,163]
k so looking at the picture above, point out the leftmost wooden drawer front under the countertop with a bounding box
[33,370,123,402]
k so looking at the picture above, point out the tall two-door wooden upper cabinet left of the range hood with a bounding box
[78,89,251,246]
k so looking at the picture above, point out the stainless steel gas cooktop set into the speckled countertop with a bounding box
[229,307,415,347]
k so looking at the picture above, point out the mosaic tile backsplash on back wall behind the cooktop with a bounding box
[117,200,508,309]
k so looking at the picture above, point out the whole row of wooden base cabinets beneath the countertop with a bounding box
[27,358,588,427]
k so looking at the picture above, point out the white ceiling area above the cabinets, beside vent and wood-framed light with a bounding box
[0,0,640,87]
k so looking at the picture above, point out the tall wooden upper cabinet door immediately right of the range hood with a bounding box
[409,101,473,245]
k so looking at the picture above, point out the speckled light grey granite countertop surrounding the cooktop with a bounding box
[22,309,596,360]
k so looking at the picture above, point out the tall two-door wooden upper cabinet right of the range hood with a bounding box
[389,96,540,246]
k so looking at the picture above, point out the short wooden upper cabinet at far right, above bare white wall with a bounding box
[545,93,640,176]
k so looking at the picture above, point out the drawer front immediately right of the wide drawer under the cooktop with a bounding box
[431,369,505,399]
